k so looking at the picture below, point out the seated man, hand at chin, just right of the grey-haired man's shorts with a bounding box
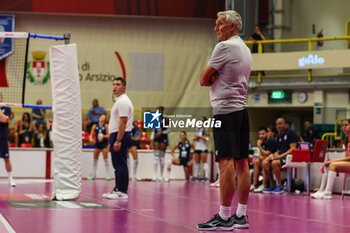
[253,127,277,193]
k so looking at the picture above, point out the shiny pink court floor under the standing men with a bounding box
[0,179,350,233]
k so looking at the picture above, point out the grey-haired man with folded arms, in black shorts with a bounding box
[197,11,252,230]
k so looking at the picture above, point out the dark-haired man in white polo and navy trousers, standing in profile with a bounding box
[102,77,134,199]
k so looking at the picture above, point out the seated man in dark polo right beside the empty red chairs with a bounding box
[264,117,299,194]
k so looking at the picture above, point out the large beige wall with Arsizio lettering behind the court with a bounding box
[13,13,217,109]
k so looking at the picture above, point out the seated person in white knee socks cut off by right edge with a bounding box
[311,119,350,199]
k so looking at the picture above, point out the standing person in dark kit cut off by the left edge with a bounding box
[0,93,16,187]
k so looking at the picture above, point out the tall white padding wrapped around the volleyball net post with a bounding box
[50,44,82,200]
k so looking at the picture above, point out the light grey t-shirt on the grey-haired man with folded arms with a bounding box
[208,36,252,115]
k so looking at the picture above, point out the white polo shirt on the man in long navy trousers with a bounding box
[108,94,134,133]
